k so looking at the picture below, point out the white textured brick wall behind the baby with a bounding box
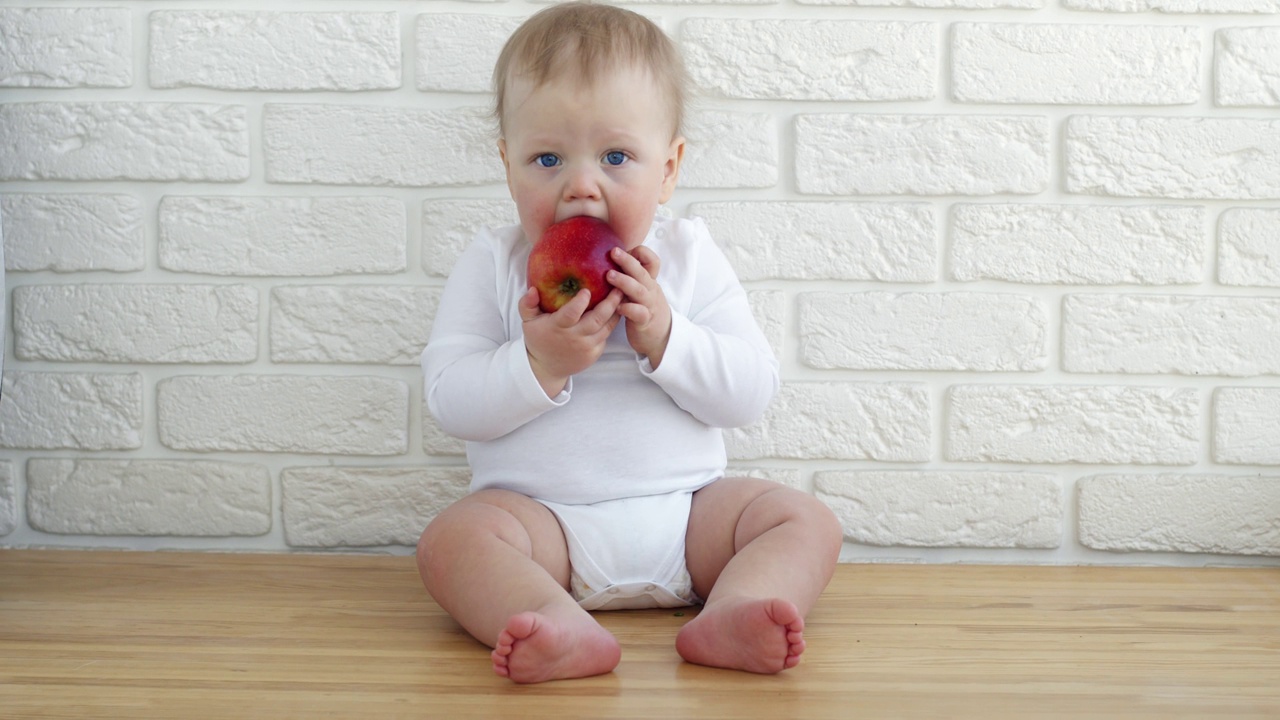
[0,0,1280,565]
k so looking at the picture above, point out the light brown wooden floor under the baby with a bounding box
[0,551,1280,719]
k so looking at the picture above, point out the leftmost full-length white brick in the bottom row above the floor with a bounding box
[27,459,271,537]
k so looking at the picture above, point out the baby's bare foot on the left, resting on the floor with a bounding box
[490,612,622,683]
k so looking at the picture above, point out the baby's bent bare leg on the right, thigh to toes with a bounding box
[676,478,844,673]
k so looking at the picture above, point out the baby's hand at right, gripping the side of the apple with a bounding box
[608,245,671,368]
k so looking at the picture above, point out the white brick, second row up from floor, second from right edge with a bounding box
[946,384,1201,465]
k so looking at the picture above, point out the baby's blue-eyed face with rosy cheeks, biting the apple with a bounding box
[498,68,685,250]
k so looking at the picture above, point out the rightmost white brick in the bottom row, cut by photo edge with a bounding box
[1079,474,1280,555]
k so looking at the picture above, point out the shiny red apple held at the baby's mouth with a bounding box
[529,215,622,313]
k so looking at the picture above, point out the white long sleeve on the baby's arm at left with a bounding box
[422,231,568,441]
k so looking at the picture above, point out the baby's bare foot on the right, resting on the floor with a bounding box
[676,598,804,674]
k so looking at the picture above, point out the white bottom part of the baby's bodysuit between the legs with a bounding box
[541,491,700,611]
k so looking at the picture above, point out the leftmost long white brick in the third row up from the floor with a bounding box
[13,284,257,363]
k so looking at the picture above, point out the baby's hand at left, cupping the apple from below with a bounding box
[520,287,622,397]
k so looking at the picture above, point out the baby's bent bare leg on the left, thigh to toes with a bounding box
[417,491,621,683]
